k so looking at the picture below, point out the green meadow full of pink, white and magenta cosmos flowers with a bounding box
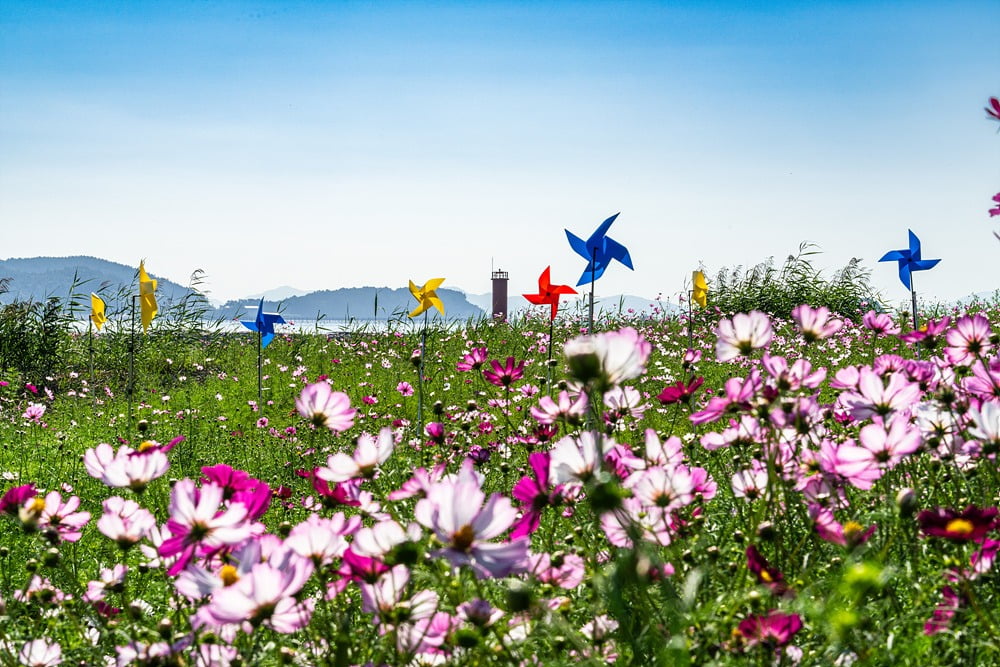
[0,303,1000,667]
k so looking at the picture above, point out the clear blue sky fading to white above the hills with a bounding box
[0,0,1000,302]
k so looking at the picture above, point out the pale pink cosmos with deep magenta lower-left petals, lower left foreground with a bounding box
[158,479,251,576]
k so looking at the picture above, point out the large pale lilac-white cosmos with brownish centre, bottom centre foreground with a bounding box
[414,463,529,578]
